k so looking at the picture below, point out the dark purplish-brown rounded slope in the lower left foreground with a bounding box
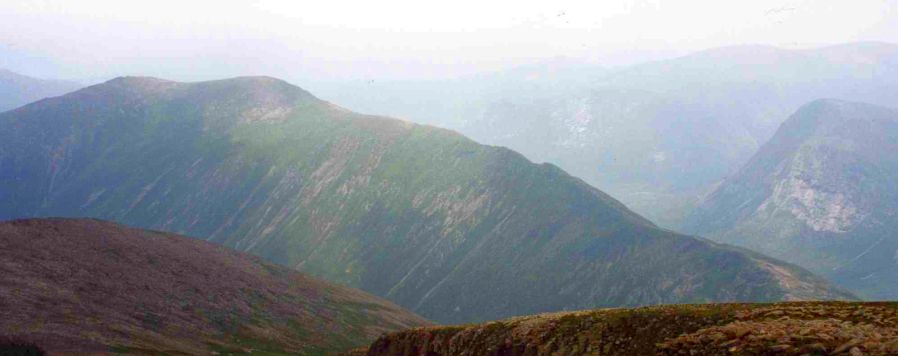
[0,219,429,354]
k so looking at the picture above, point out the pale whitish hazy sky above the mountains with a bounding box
[0,0,898,80]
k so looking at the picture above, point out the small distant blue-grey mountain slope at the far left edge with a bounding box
[0,69,81,112]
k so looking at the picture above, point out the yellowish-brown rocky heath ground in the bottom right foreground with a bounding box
[360,302,898,355]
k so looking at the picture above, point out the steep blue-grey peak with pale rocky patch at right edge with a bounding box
[685,99,898,299]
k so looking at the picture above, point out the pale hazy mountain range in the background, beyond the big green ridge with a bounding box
[310,43,898,227]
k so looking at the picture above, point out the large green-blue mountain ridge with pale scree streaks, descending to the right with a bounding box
[0,77,851,322]
